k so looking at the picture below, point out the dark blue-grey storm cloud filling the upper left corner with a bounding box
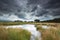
[0,0,20,14]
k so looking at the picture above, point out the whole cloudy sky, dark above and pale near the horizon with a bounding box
[0,0,60,21]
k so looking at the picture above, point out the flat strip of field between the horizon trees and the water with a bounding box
[0,22,60,26]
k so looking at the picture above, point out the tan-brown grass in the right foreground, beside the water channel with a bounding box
[36,24,60,40]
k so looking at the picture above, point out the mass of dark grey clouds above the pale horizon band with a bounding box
[0,0,60,18]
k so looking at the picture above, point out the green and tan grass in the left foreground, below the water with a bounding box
[0,28,31,40]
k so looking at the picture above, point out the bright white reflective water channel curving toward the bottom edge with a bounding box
[6,24,41,40]
